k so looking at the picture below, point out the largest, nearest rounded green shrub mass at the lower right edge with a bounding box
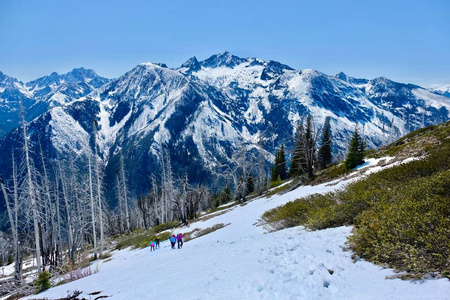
[349,170,450,277]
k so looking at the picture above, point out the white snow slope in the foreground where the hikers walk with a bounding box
[30,160,450,299]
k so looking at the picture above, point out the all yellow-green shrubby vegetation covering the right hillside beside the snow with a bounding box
[262,122,450,278]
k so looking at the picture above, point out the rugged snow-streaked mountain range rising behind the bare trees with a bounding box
[0,52,450,204]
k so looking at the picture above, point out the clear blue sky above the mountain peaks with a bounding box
[0,0,450,86]
